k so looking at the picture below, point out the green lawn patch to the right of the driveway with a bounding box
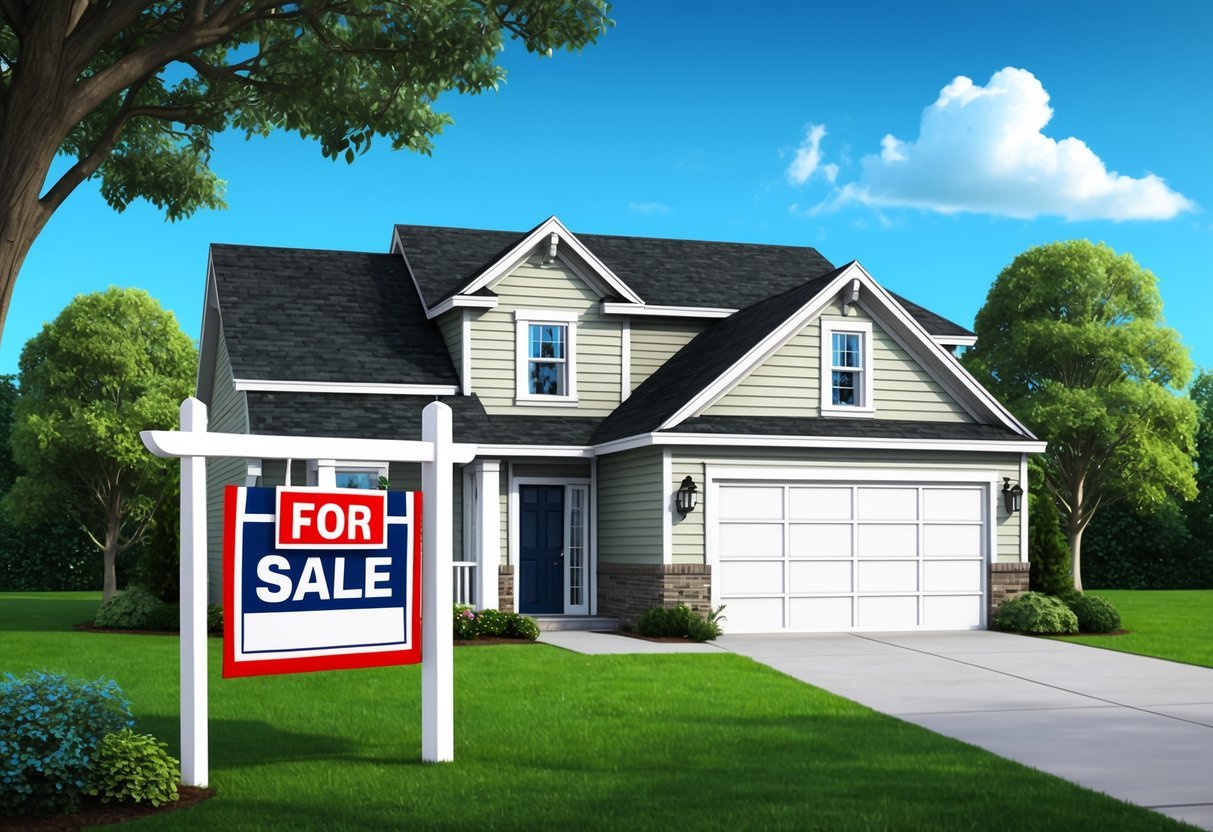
[1065,589,1213,667]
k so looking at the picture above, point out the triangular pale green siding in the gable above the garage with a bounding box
[706,298,973,422]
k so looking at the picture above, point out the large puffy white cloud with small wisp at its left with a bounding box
[824,67,1196,220]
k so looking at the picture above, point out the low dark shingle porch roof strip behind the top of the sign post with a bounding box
[247,392,599,445]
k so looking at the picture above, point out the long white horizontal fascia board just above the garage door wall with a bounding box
[594,433,1047,456]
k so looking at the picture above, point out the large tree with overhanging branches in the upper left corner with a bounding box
[0,0,611,344]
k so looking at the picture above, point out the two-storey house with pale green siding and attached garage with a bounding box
[191,217,1044,632]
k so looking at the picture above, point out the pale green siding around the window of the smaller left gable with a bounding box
[471,256,622,416]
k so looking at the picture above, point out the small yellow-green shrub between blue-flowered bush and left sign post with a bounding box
[89,728,181,807]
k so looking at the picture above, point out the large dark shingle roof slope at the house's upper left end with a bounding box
[211,245,459,384]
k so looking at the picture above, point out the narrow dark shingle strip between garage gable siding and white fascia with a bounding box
[664,416,1024,441]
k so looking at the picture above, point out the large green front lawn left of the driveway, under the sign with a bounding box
[0,593,1186,832]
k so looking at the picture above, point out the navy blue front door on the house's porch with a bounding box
[518,485,564,612]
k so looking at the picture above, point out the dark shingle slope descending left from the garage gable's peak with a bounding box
[594,266,847,443]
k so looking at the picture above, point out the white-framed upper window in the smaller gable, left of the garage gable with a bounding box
[514,310,577,404]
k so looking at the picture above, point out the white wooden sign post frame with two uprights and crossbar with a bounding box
[139,398,475,786]
